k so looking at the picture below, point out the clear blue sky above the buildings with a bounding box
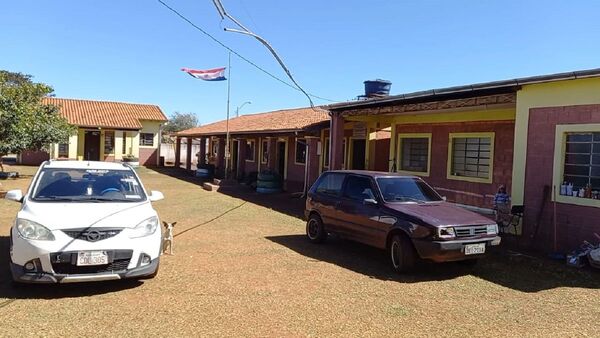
[0,0,600,124]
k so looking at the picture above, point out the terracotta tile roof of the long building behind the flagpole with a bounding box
[178,108,329,136]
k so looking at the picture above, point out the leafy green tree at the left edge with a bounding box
[0,70,76,171]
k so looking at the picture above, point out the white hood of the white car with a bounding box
[17,201,156,230]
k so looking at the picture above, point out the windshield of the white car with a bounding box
[32,168,146,202]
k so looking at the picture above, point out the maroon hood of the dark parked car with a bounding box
[386,202,494,226]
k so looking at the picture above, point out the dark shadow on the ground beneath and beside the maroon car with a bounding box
[266,235,600,292]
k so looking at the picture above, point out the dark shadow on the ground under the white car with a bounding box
[0,236,143,300]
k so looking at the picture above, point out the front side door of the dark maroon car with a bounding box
[336,175,383,245]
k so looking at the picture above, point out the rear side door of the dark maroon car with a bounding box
[309,173,346,232]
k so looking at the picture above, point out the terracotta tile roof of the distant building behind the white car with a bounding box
[43,97,167,129]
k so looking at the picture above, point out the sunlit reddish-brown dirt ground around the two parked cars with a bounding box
[0,167,600,337]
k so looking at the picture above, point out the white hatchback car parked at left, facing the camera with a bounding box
[5,161,163,283]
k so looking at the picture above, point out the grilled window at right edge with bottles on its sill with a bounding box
[563,132,600,190]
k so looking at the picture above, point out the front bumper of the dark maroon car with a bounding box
[413,236,501,262]
